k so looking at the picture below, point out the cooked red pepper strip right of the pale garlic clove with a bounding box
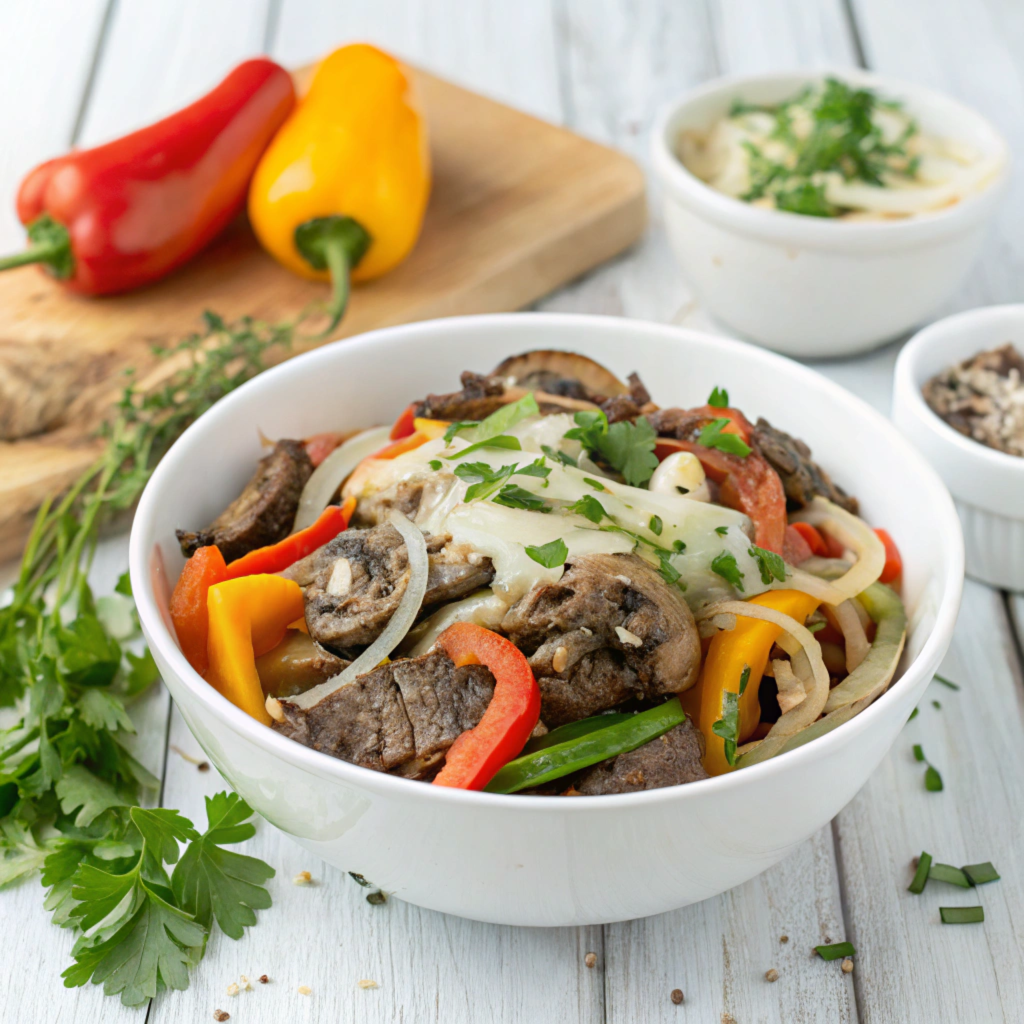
[654,437,786,555]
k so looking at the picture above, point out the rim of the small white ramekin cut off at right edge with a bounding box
[893,303,1024,476]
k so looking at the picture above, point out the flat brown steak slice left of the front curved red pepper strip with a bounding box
[273,650,495,777]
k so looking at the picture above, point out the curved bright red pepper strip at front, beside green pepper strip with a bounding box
[434,623,541,790]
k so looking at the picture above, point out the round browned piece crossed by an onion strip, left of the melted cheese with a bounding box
[286,523,495,647]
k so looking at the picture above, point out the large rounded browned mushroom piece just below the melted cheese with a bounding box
[502,555,700,726]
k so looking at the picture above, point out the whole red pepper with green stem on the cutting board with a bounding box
[0,57,295,295]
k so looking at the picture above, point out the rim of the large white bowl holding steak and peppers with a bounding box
[128,312,964,814]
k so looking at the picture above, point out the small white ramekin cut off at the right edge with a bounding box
[893,305,1024,590]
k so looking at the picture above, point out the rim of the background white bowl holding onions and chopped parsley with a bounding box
[650,66,1011,248]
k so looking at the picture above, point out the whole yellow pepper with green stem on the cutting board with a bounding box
[249,43,430,330]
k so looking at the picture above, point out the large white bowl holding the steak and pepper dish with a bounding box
[130,313,964,925]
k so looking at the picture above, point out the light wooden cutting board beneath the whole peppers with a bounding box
[0,70,645,561]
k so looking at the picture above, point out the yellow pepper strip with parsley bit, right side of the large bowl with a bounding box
[696,590,818,775]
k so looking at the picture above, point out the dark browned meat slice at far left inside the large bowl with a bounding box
[176,440,313,562]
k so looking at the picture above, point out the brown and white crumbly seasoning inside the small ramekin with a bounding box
[922,343,1024,456]
